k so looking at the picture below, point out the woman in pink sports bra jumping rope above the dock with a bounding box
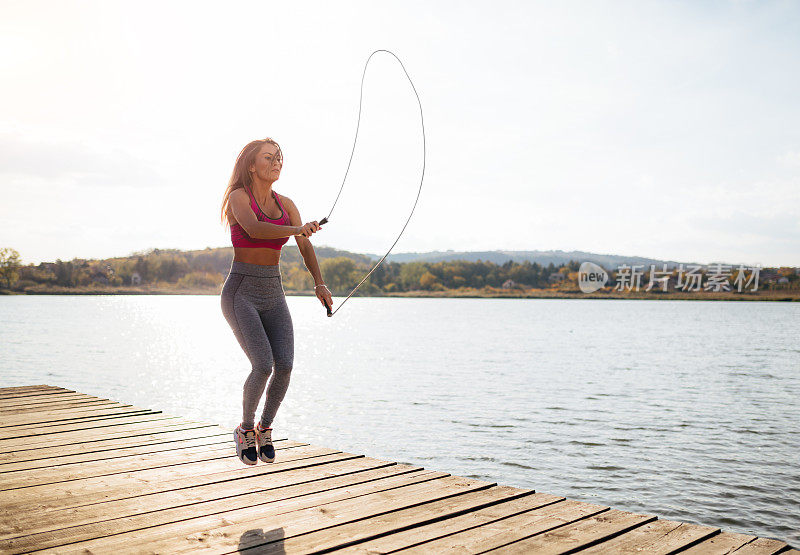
[221,138,333,465]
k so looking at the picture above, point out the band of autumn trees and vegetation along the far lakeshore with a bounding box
[0,246,800,301]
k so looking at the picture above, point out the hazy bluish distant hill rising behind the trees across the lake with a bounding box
[366,250,695,270]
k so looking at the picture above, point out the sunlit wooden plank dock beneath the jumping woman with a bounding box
[0,385,798,555]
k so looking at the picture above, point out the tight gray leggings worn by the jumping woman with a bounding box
[221,261,294,429]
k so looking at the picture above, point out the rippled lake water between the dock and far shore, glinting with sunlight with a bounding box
[0,296,800,546]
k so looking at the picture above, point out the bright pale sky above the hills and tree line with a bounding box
[0,0,800,266]
